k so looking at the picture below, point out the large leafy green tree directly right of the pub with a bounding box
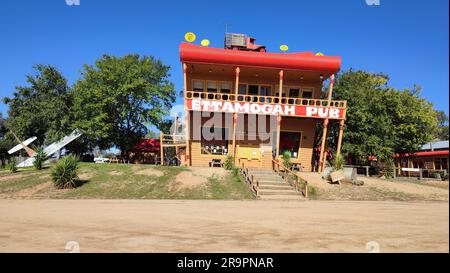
[330,69,437,160]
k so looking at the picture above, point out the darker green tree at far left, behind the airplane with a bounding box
[3,65,71,146]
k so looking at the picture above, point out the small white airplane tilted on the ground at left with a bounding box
[8,129,84,167]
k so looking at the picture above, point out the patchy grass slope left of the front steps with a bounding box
[0,163,253,200]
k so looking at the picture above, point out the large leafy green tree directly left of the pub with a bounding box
[74,54,175,154]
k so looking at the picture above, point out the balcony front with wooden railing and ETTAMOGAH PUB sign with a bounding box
[185,91,347,119]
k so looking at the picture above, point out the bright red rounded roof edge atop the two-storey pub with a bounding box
[180,42,341,74]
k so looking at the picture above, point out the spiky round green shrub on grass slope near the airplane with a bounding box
[52,155,79,189]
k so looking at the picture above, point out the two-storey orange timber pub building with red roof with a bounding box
[174,33,347,171]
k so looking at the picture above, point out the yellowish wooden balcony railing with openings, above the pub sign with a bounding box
[185,91,347,109]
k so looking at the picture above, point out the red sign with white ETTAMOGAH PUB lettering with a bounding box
[186,99,344,119]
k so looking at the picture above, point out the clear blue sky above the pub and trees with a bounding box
[0,0,449,117]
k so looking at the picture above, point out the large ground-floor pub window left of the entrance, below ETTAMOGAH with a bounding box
[201,127,228,155]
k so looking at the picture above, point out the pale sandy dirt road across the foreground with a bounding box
[0,200,449,252]
